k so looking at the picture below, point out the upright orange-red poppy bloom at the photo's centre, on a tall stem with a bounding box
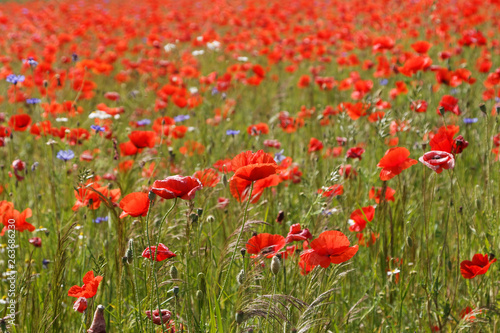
[231,150,278,181]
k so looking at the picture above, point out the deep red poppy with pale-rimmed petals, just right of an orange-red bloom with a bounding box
[151,175,203,200]
